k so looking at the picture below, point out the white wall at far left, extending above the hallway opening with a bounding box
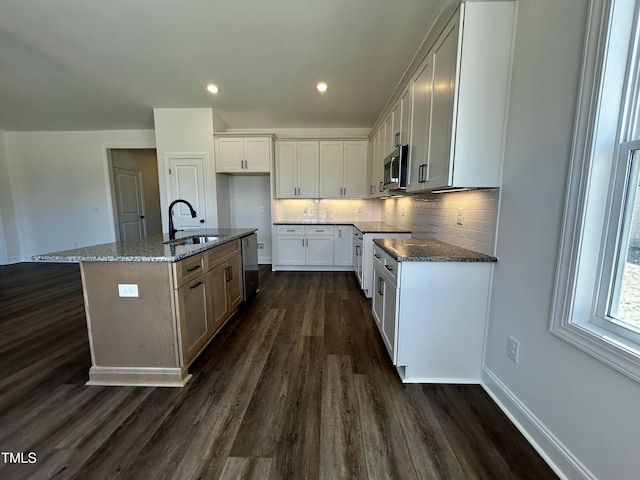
[2,130,155,261]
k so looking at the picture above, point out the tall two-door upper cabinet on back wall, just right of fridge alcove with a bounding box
[275,141,320,198]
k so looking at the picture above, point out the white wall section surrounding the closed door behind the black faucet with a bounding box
[153,108,218,232]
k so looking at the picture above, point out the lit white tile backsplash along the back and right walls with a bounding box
[273,189,500,255]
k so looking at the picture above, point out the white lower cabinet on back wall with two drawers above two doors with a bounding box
[276,225,335,266]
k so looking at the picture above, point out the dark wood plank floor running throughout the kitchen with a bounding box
[0,264,557,480]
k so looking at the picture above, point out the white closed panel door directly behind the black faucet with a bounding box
[168,155,207,230]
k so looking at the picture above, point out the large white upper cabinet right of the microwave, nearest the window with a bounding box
[407,2,515,191]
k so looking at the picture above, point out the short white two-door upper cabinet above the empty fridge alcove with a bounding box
[216,135,273,173]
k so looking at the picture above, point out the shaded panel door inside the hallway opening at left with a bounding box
[113,167,147,242]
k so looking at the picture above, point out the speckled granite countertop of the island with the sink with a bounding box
[32,228,257,262]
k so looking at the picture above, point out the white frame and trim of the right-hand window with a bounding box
[549,0,640,381]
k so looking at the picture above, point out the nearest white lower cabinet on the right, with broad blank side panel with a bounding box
[372,245,493,383]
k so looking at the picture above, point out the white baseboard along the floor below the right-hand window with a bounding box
[480,367,596,480]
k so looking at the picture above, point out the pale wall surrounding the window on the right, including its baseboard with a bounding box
[483,0,640,480]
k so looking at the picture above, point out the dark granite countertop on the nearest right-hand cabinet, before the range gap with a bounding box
[373,238,498,262]
